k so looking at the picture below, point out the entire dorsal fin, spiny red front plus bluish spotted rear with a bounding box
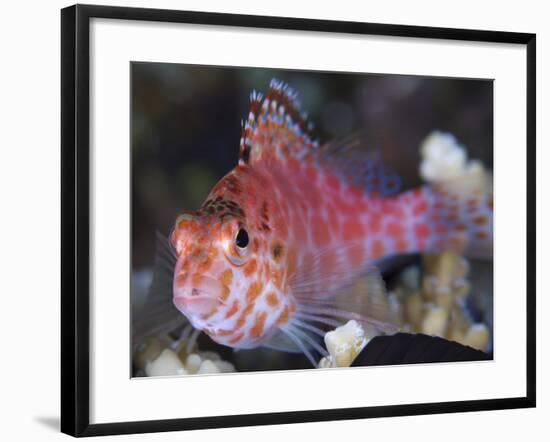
[239,79,400,196]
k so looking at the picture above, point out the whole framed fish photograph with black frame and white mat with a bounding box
[61,5,536,436]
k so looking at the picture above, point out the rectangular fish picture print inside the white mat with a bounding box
[130,62,493,377]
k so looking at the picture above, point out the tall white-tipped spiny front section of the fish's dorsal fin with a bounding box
[239,79,319,165]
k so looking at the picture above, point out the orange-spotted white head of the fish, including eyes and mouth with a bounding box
[171,207,288,348]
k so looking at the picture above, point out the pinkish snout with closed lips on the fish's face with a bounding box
[174,274,225,319]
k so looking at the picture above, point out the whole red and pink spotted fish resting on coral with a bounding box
[171,80,493,363]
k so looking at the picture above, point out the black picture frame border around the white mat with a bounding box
[61,5,536,436]
